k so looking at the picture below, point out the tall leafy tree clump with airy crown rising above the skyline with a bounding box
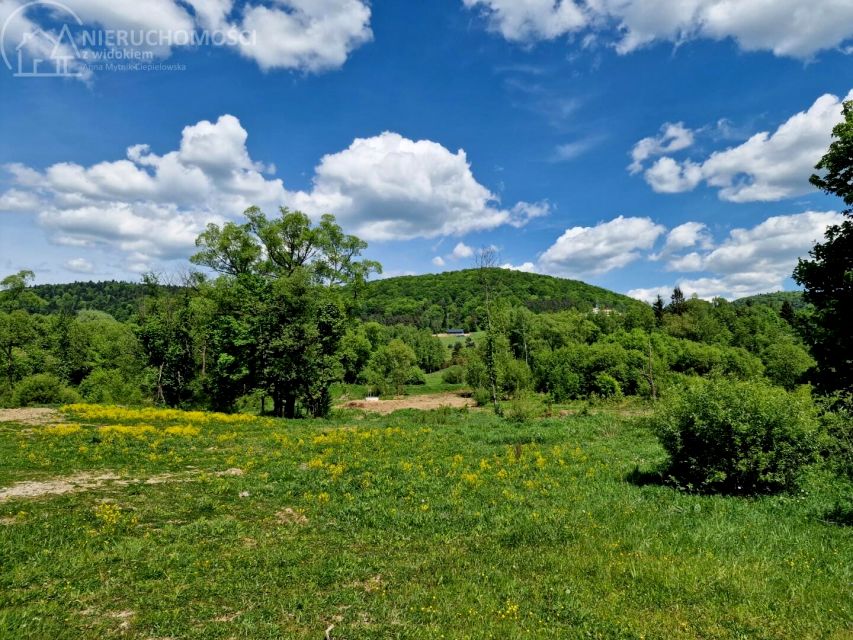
[191,207,381,417]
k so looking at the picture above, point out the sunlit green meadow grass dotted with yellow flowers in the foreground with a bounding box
[0,410,853,639]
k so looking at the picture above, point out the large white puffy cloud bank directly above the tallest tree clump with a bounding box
[0,114,549,270]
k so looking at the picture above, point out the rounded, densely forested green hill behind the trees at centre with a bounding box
[361,269,643,330]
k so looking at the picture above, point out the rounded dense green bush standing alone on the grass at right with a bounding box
[652,379,821,494]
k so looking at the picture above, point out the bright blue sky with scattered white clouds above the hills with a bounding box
[0,0,853,298]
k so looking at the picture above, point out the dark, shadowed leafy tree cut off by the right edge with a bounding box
[794,101,853,391]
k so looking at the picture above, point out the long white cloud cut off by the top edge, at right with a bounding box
[463,0,853,59]
